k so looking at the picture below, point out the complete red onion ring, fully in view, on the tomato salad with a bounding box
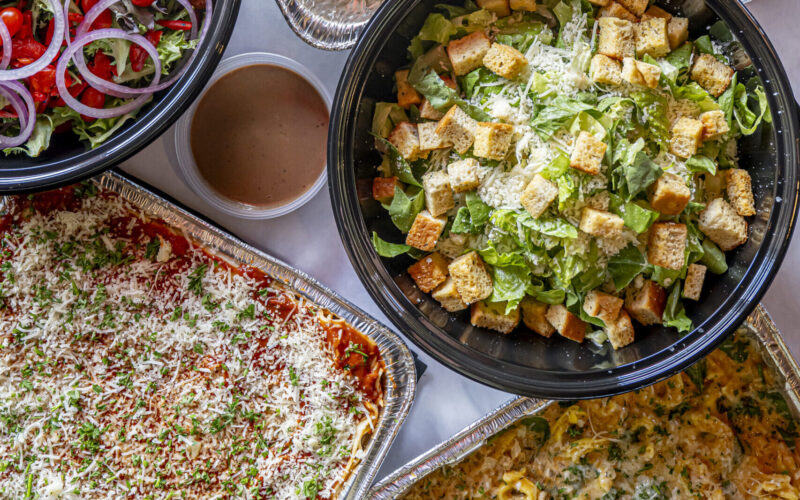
[56,28,161,118]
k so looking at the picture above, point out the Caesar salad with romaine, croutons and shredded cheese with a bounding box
[372,0,770,349]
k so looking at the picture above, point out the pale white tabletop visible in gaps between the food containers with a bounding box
[122,0,800,484]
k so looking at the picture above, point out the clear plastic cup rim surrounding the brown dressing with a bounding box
[175,52,331,219]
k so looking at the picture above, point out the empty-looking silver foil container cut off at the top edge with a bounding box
[275,0,383,50]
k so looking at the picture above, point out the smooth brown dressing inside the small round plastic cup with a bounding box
[191,64,328,208]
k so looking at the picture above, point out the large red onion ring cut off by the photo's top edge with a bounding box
[74,0,212,96]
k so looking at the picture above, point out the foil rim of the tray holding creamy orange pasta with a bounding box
[367,305,800,500]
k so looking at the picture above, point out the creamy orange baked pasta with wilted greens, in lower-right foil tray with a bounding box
[404,334,800,500]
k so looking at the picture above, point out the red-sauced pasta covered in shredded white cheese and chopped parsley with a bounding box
[0,184,384,500]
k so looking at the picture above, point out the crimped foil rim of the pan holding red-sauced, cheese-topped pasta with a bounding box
[92,172,417,500]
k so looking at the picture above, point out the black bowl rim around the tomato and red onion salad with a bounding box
[0,0,240,193]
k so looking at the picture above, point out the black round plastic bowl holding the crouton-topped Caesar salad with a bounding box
[328,0,800,399]
